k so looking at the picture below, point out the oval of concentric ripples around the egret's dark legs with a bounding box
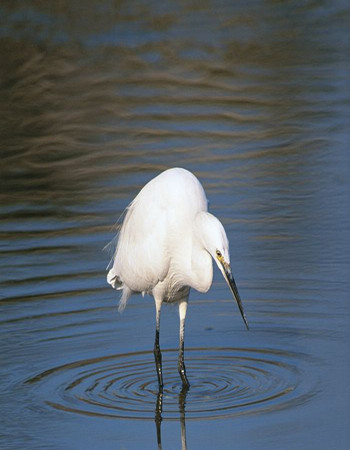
[26,348,316,420]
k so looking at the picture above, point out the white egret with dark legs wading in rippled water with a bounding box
[107,167,249,390]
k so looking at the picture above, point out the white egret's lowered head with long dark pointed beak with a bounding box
[201,213,249,329]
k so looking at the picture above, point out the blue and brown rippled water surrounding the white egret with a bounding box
[0,1,350,449]
